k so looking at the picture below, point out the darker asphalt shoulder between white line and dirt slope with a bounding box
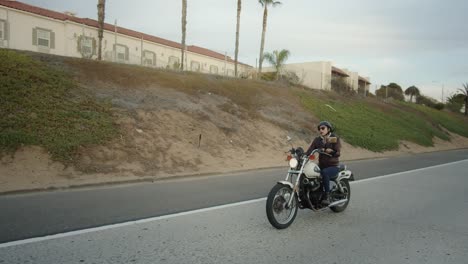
[0,150,468,243]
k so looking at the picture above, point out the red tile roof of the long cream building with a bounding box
[0,0,251,67]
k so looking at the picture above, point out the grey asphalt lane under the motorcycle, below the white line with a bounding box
[0,160,468,264]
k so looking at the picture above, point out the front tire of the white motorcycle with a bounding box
[266,183,298,229]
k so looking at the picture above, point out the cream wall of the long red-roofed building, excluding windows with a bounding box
[0,6,252,76]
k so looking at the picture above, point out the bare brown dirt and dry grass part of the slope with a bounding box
[0,51,468,192]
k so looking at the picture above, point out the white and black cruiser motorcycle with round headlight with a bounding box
[266,136,354,229]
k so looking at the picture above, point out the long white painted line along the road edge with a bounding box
[0,159,468,249]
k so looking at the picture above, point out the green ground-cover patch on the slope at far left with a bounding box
[0,49,116,162]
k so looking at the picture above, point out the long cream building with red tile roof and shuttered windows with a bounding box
[0,0,252,76]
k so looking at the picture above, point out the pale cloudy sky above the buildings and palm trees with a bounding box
[21,0,468,100]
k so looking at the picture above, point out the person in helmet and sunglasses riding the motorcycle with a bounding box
[306,121,341,205]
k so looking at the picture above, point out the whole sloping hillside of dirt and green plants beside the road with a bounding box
[0,49,468,192]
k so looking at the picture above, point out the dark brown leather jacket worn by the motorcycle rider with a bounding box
[306,133,341,169]
